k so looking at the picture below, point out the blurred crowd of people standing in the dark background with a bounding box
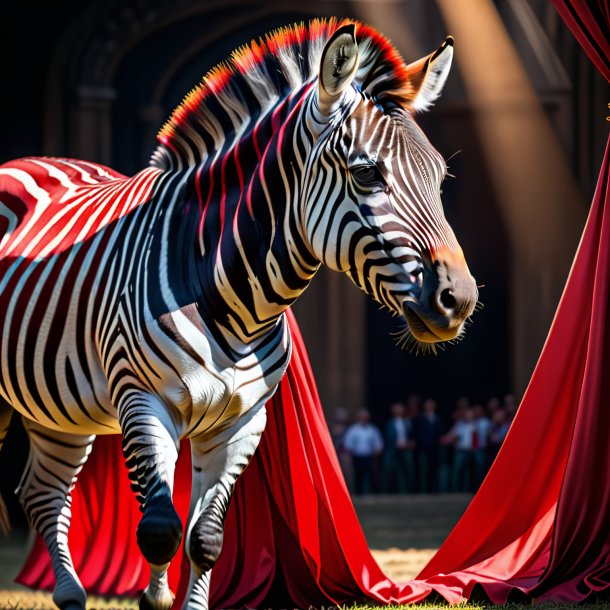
[331,394,517,495]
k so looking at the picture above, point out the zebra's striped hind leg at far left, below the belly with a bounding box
[17,418,95,610]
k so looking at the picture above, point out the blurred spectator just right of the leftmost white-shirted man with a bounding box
[382,402,415,493]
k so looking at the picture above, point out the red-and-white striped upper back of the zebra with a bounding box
[0,157,160,260]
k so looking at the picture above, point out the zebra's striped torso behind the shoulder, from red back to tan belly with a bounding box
[0,158,160,433]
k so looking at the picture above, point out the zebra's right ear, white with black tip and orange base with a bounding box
[407,36,453,112]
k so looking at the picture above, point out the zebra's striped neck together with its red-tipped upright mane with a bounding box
[144,18,411,342]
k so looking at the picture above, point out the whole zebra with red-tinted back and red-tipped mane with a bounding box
[0,18,477,610]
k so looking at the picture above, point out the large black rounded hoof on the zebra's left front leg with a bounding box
[136,495,182,565]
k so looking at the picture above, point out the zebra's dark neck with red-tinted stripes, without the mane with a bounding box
[160,85,319,344]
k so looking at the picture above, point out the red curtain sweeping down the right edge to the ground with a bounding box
[420,138,610,603]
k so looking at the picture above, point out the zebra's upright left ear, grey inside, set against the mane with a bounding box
[318,23,358,115]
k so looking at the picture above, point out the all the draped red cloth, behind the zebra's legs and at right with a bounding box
[18,0,610,608]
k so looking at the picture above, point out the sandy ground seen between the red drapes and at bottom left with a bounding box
[0,494,470,610]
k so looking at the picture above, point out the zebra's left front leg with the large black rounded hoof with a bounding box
[119,392,182,610]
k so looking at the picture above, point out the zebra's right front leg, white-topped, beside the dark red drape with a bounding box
[184,406,267,610]
